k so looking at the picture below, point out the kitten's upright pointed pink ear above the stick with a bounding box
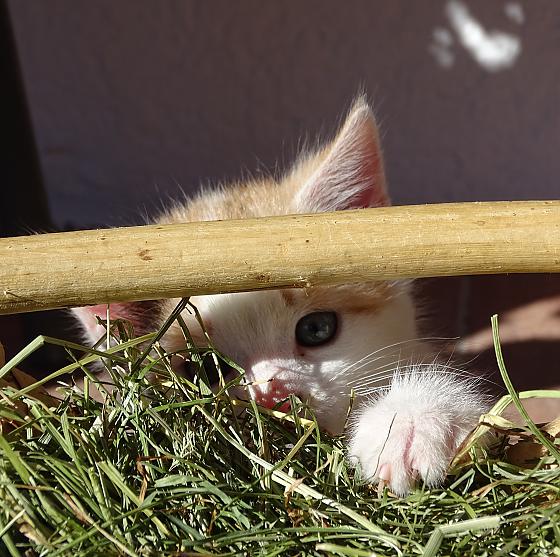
[296,99,390,213]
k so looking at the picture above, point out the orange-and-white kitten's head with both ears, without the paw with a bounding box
[75,100,416,433]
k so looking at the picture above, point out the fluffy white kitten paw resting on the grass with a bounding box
[348,365,487,495]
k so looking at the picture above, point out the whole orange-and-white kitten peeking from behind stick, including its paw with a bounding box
[74,99,485,495]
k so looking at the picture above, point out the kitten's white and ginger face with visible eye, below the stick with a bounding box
[166,283,416,433]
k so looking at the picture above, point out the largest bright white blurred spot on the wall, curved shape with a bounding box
[446,0,521,71]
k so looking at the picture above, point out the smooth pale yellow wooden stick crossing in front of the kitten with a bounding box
[0,201,560,313]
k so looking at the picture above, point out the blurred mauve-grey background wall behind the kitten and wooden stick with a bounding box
[4,0,560,414]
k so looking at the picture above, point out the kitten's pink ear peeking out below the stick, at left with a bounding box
[71,300,161,345]
